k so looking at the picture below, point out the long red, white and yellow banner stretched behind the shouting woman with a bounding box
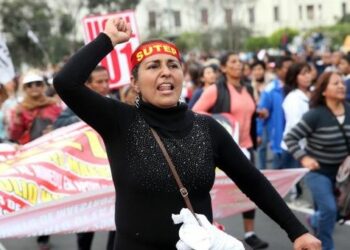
[0,122,306,238]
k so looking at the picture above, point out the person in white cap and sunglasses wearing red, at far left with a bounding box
[9,72,61,144]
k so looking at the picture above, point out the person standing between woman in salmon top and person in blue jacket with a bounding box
[250,60,269,169]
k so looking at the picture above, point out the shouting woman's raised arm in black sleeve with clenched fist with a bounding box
[54,19,131,136]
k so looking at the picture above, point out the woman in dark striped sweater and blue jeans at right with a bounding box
[284,72,350,250]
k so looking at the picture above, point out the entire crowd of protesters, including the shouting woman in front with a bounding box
[0,15,350,250]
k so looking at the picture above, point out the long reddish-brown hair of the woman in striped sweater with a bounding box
[310,72,338,108]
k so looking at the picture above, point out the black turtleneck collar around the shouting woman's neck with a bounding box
[139,100,194,138]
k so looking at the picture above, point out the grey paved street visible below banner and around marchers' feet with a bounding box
[0,208,350,250]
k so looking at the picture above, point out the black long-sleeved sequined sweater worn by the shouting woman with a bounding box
[54,33,307,246]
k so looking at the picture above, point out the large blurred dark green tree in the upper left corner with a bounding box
[0,0,139,67]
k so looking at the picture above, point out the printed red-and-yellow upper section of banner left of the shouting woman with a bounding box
[0,123,113,214]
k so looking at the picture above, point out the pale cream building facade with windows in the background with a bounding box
[136,0,350,37]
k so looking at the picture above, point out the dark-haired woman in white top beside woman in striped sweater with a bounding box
[281,62,312,205]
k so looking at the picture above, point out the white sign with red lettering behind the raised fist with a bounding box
[83,10,140,88]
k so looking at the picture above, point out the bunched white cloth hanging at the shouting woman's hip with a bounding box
[172,208,244,250]
